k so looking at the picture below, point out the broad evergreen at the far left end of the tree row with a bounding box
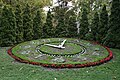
[0,6,16,46]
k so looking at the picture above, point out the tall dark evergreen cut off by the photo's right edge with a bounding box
[104,0,120,48]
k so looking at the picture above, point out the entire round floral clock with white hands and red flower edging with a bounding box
[8,38,112,68]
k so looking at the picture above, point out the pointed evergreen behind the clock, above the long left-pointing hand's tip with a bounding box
[43,10,54,38]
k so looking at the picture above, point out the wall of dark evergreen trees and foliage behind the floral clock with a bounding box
[0,0,120,48]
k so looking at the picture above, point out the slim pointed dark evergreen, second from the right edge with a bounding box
[97,5,109,43]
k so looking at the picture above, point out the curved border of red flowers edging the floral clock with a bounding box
[7,42,113,68]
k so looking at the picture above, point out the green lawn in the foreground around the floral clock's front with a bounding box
[0,48,120,80]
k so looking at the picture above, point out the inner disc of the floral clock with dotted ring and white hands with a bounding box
[37,39,85,57]
